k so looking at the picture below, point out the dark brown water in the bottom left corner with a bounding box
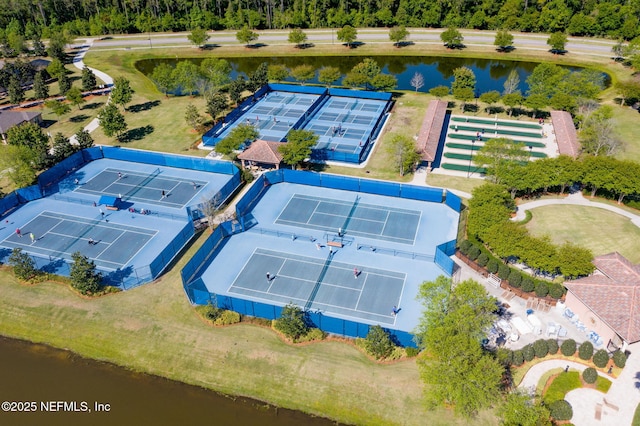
[0,337,336,426]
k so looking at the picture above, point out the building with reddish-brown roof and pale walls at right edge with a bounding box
[565,252,640,350]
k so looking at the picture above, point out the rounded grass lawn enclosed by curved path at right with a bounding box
[526,205,640,263]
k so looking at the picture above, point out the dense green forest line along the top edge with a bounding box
[0,0,640,42]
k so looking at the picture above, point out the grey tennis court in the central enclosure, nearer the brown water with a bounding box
[228,248,406,325]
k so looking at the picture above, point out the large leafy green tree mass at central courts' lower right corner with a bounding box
[416,276,504,416]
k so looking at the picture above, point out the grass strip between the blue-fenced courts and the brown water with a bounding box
[0,233,497,425]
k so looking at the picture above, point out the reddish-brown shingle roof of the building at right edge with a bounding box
[565,252,640,343]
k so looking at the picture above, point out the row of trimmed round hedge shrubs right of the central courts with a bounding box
[459,240,565,299]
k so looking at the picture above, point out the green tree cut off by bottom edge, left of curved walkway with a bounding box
[497,390,550,426]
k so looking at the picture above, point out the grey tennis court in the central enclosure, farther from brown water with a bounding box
[275,194,422,244]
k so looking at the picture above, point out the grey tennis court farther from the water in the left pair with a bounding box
[74,168,207,208]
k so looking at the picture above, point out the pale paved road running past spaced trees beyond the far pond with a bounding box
[79,28,615,57]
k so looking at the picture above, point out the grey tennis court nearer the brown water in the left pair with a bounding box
[1,211,157,270]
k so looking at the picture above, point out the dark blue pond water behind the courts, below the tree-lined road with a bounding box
[136,56,609,94]
